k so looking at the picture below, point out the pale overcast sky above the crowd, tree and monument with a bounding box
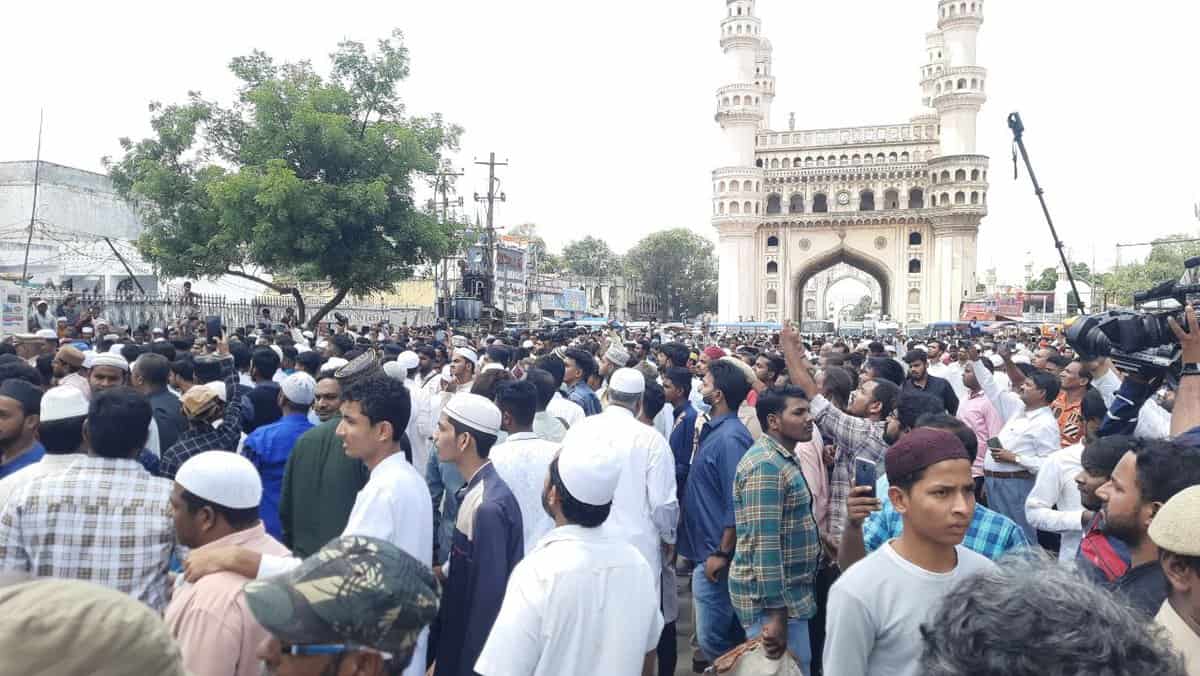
[0,0,1200,288]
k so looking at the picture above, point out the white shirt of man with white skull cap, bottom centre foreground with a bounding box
[475,525,664,676]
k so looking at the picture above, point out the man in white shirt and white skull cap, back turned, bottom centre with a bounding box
[474,434,664,676]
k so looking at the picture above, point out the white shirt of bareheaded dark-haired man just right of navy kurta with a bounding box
[487,432,562,555]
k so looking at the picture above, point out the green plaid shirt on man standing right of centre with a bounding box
[730,435,821,627]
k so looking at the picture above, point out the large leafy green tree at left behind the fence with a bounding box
[104,30,461,324]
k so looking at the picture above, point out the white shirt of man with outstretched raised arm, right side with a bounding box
[972,361,1062,473]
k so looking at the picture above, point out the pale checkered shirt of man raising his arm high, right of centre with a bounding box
[812,395,888,545]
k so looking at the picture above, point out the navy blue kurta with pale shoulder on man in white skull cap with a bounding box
[434,462,524,676]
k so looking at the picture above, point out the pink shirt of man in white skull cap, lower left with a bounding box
[164,521,290,676]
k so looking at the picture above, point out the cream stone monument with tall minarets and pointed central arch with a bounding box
[713,0,988,323]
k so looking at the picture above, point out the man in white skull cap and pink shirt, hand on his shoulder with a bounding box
[164,451,288,676]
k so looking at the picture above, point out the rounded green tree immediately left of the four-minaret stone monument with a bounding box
[625,228,716,319]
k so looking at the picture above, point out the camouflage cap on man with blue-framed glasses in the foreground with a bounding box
[244,536,439,659]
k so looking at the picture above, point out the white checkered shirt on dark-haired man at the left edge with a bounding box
[0,457,175,612]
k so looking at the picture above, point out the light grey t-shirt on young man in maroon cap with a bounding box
[822,543,995,676]
